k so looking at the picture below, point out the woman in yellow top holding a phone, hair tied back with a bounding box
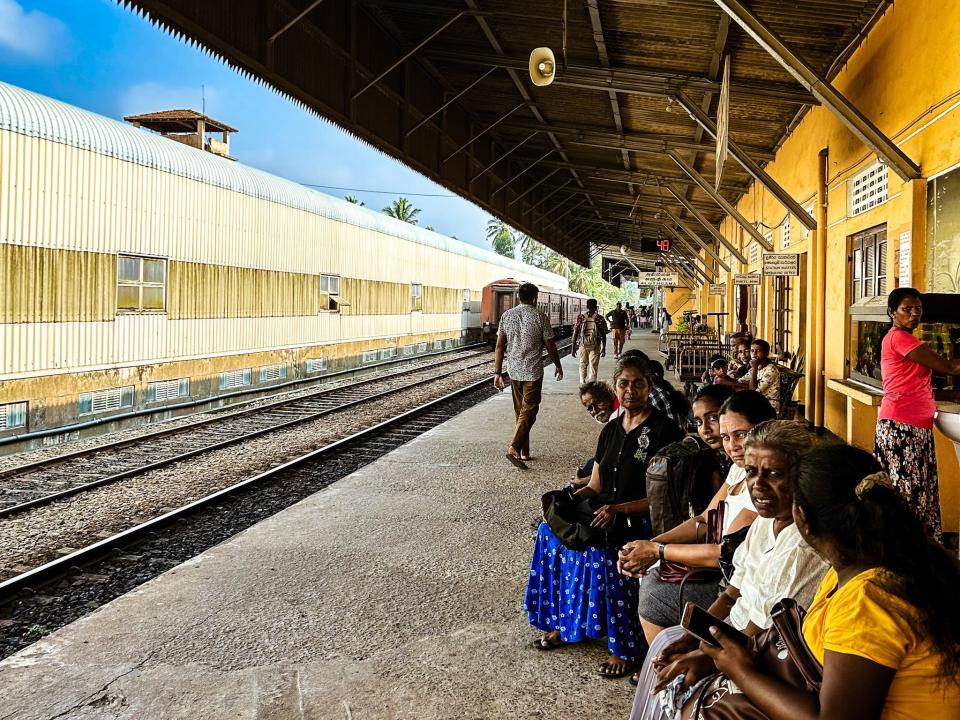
[696,444,960,720]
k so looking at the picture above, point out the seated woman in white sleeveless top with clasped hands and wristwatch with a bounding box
[620,394,776,643]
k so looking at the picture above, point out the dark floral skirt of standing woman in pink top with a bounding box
[873,420,943,542]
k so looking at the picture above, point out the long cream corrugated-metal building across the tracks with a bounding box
[0,83,567,444]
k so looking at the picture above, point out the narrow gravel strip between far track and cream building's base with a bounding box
[0,350,484,472]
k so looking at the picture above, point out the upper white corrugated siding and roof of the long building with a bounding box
[0,83,566,287]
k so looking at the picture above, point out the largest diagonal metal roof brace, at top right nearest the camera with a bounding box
[714,0,920,183]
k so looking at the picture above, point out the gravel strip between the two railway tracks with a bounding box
[0,367,490,579]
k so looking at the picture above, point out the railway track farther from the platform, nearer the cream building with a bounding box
[0,352,490,518]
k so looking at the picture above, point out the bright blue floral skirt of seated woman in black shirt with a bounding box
[523,523,647,662]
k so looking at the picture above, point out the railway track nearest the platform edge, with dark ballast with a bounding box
[0,338,569,658]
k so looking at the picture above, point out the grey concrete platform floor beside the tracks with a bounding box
[0,332,656,720]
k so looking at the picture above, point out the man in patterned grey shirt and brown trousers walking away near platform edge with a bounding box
[493,283,563,470]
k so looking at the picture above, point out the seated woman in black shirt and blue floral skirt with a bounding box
[523,357,682,677]
